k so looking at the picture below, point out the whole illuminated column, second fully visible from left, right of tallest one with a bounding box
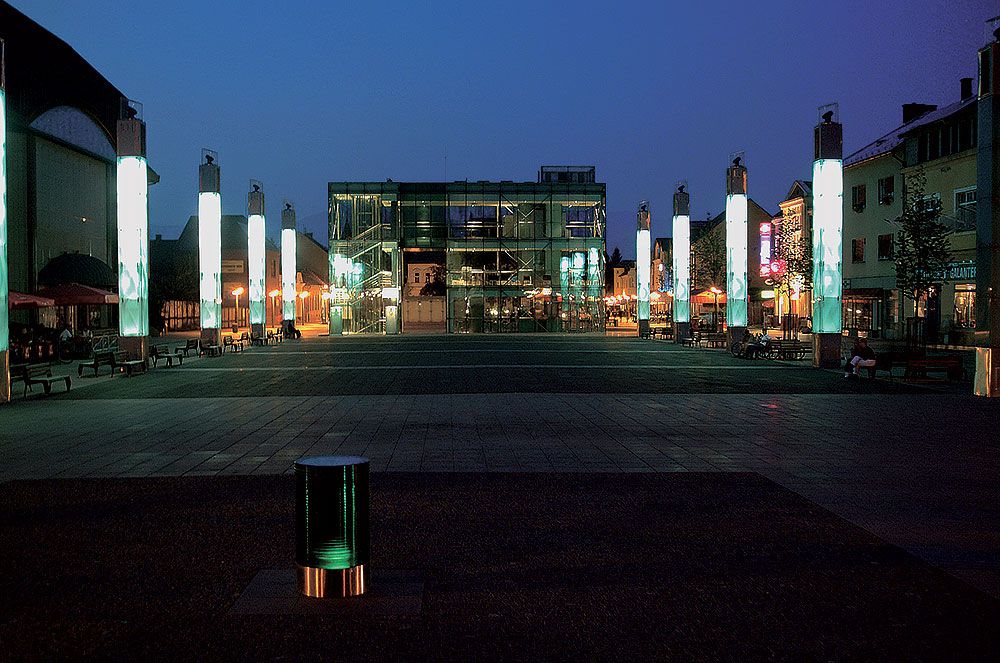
[198,150,222,345]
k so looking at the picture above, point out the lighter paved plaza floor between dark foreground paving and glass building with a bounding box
[0,336,1000,595]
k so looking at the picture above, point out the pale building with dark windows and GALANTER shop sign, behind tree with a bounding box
[843,79,978,344]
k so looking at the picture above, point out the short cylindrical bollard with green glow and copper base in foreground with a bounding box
[295,456,371,598]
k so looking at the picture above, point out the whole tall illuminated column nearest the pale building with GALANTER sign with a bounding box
[812,105,844,368]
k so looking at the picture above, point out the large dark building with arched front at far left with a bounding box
[0,1,159,337]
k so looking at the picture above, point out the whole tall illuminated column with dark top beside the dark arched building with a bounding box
[115,100,149,359]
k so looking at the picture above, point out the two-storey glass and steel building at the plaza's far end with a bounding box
[329,167,606,333]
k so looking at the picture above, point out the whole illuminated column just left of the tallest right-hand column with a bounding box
[726,156,747,342]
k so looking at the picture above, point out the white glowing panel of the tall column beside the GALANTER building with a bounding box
[813,159,844,334]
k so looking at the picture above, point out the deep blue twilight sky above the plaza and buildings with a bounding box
[12,0,998,255]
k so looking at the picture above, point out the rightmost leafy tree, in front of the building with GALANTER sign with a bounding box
[894,170,952,334]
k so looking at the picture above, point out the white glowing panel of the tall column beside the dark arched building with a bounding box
[116,156,149,336]
